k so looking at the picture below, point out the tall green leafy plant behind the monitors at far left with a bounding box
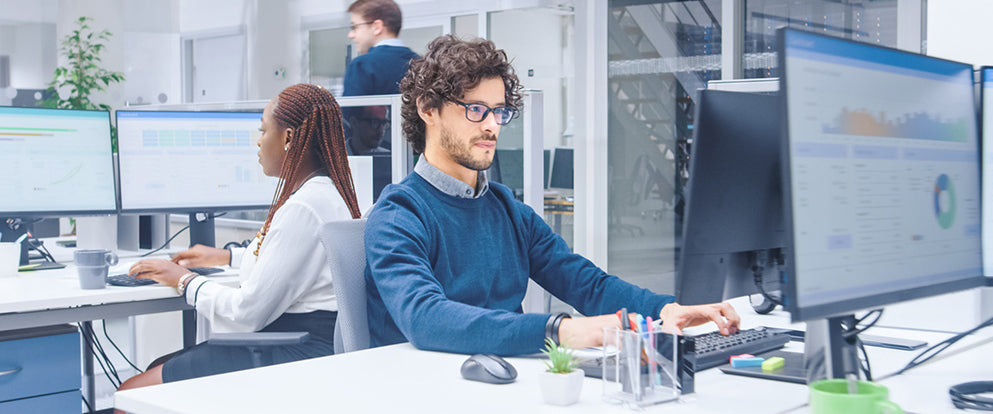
[42,16,124,111]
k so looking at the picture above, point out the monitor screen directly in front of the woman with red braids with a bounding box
[117,111,277,212]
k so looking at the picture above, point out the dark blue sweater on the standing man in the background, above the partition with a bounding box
[342,45,418,96]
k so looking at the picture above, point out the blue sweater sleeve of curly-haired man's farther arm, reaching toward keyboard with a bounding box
[518,204,675,318]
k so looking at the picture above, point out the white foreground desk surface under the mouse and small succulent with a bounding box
[115,300,993,414]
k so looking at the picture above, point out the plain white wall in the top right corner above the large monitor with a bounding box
[927,0,993,66]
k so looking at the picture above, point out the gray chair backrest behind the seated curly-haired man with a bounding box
[320,218,369,354]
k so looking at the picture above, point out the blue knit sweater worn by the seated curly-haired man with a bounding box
[365,173,673,355]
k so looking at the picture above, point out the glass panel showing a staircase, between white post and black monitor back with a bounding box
[605,0,722,298]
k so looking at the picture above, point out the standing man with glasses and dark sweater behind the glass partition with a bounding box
[341,0,419,155]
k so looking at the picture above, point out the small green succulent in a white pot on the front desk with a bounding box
[538,338,585,405]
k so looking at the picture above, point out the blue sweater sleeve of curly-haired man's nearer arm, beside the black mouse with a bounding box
[365,193,549,355]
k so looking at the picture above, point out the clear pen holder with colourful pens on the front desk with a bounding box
[603,328,680,407]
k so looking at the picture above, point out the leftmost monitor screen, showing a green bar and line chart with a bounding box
[0,107,117,217]
